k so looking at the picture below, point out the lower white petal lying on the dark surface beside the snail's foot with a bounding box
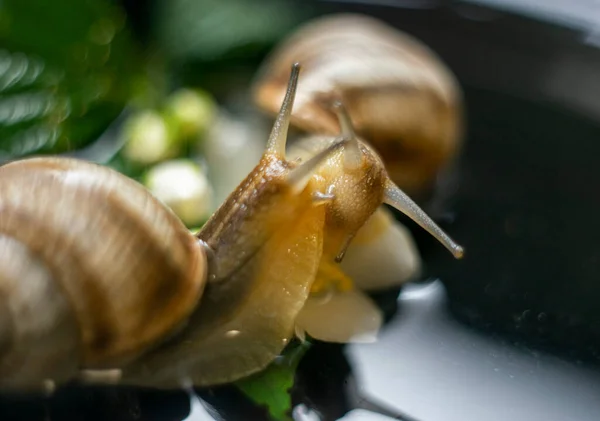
[296,291,383,343]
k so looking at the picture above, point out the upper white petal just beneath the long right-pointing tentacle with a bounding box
[341,207,421,291]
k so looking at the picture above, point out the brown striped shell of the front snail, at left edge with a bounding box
[0,157,207,388]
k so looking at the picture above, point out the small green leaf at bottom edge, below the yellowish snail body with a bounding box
[236,342,310,421]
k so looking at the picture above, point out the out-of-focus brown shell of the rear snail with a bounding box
[253,14,463,196]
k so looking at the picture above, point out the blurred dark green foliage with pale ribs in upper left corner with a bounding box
[0,0,141,159]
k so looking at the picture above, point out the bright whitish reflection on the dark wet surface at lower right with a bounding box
[343,281,600,421]
